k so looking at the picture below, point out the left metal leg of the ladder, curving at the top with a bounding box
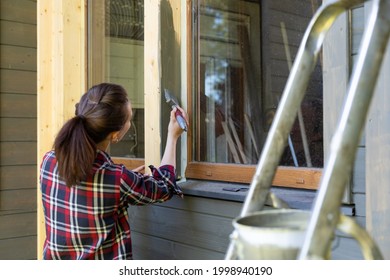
[225,0,364,259]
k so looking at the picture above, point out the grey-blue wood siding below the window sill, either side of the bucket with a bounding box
[129,190,363,260]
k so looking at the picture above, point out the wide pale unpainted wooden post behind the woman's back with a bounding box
[37,0,86,259]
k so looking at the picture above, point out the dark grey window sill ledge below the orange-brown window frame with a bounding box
[178,179,355,216]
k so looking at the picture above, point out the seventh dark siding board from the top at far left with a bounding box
[0,142,37,166]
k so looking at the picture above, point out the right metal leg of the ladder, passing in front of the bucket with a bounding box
[299,0,390,259]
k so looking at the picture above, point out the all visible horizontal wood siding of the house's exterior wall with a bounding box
[0,0,389,259]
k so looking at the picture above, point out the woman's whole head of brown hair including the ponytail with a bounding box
[54,83,129,186]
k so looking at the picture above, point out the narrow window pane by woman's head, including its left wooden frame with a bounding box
[88,0,144,158]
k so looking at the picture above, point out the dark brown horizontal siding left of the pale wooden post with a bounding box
[0,0,37,259]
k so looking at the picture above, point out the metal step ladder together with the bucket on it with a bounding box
[225,0,390,259]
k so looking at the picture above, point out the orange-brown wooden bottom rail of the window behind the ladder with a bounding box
[186,162,322,190]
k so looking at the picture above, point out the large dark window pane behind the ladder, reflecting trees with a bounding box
[193,0,323,167]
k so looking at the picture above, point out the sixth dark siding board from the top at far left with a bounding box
[0,118,37,142]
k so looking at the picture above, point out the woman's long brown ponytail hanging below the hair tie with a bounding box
[54,116,96,186]
